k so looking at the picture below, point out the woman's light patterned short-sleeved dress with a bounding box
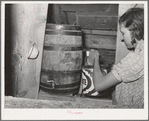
[112,40,144,108]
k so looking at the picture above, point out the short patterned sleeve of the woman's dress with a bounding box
[112,52,144,82]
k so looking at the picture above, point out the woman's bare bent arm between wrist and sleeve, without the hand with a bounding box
[93,56,120,91]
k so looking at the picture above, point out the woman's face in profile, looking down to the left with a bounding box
[120,24,134,49]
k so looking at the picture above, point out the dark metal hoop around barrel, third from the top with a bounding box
[44,45,82,51]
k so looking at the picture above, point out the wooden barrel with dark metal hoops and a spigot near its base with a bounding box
[40,23,82,94]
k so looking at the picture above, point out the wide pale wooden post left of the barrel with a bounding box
[10,4,48,98]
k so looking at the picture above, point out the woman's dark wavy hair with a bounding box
[119,8,144,44]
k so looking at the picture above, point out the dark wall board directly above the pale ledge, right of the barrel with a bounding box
[76,14,117,30]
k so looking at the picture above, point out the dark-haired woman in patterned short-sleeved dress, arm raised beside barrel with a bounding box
[90,8,144,108]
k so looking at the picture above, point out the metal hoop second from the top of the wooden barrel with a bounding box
[45,29,82,36]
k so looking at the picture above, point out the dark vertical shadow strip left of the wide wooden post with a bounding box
[5,4,14,96]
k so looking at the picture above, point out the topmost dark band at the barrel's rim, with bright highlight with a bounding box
[46,23,81,30]
